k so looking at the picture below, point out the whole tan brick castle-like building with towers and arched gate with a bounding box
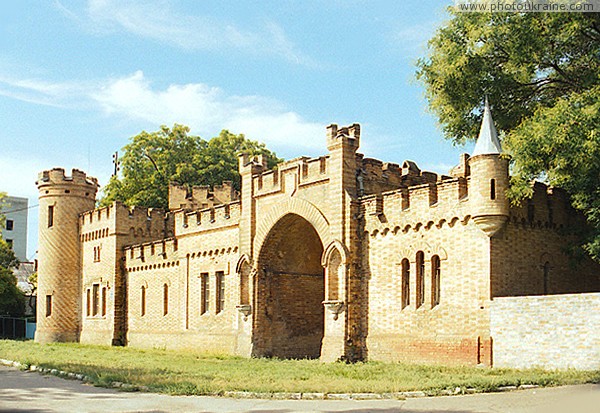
[36,104,600,365]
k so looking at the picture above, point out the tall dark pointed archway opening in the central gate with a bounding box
[254,214,325,358]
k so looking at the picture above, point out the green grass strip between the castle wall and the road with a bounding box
[0,340,600,395]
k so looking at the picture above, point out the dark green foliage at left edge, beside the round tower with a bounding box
[0,239,25,317]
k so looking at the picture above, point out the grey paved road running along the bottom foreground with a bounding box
[0,366,600,413]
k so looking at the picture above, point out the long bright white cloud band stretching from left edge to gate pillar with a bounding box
[0,71,325,153]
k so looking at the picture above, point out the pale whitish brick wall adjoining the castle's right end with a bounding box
[491,293,600,370]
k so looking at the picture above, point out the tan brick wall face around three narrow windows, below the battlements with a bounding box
[363,219,489,364]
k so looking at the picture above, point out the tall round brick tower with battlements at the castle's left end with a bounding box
[35,168,98,343]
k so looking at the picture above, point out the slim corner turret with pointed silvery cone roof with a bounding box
[469,98,509,237]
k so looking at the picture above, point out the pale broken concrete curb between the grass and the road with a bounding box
[0,359,540,400]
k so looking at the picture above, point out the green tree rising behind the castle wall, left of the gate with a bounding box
[100,124,281,209]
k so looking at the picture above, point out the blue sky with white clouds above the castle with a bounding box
[0,0,472,257]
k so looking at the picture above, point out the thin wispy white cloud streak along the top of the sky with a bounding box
[61,0,316,66]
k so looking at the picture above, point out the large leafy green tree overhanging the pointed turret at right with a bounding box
[417,9,600,261]
